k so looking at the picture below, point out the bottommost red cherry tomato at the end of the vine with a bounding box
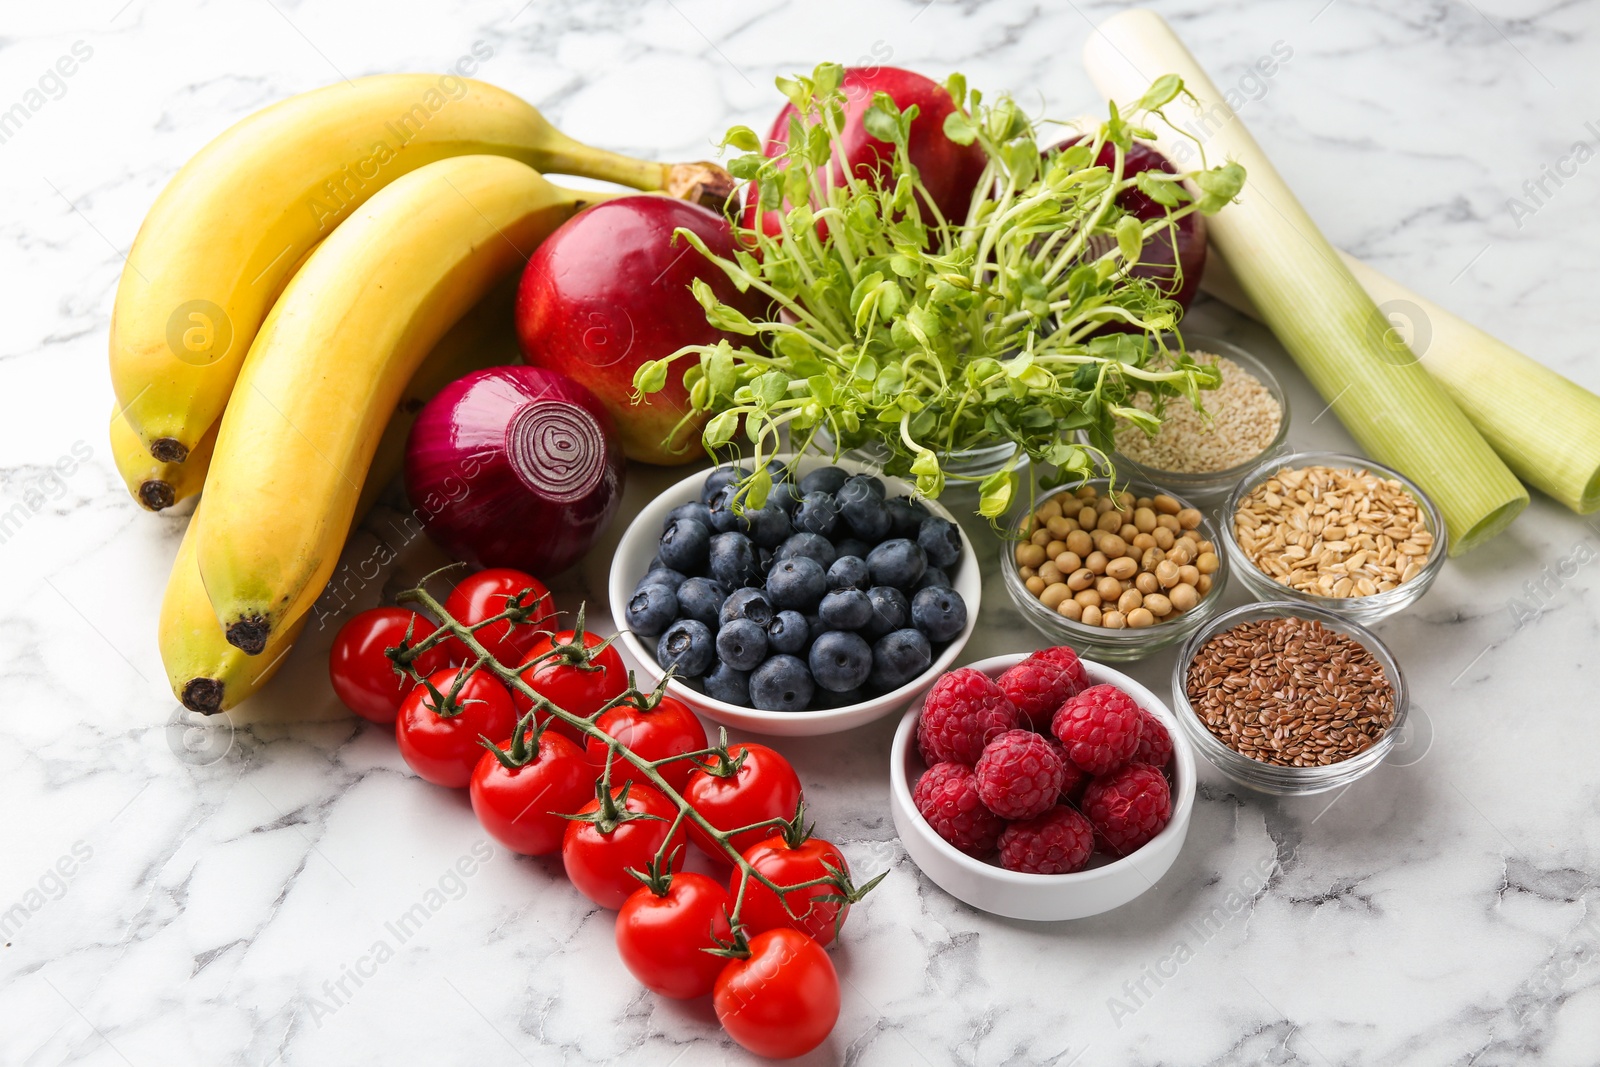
[712,929,838,1059]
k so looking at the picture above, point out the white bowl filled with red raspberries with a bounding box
[890,646,1195,921]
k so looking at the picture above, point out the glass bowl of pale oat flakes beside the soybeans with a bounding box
[1218,451,1446,624]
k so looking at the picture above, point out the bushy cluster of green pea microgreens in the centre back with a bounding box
[634,64,1245,518]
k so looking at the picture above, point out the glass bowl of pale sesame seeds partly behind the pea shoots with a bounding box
[1112,333,1290,504]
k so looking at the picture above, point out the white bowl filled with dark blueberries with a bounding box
[610,456,981,737]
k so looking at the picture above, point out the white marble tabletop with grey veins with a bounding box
[0,0,1600,1067]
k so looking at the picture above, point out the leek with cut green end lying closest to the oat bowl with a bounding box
[1085,10,1528,555]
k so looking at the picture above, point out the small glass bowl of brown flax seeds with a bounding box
[1173,600,1410,797]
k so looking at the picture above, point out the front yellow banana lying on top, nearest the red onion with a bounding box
[198,155,595,654]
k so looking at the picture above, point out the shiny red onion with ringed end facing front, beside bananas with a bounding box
[405,366,626,576]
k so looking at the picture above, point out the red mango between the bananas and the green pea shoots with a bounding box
[517,195,760,464]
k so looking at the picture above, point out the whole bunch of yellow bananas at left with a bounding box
[110,74,731,713]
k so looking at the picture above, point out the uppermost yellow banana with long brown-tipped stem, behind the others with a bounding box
[110,74,731,462]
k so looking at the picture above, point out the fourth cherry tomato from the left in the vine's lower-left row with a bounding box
[562,782,683,910]
